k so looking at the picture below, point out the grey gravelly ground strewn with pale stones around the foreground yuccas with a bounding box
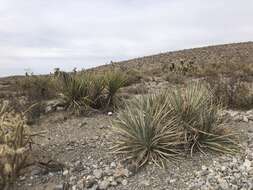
[14,110,253,190]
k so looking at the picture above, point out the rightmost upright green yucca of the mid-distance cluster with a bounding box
[106,71,127,106]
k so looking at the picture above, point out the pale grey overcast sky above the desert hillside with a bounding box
[0,0,253,76]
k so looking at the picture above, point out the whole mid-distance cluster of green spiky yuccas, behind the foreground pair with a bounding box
[59,71,126,114]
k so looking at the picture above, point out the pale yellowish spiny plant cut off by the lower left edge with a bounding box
[0,105,32,189]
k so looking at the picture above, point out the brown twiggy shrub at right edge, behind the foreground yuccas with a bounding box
[206,76,253,109]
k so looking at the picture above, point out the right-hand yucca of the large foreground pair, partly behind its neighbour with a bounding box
[168,83,239,155]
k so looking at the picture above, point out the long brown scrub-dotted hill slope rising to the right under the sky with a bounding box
[96,42,253,72]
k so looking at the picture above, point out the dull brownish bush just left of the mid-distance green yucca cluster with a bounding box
[16,75,57,101]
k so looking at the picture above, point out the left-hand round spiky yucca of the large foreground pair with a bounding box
[113,95,182,167]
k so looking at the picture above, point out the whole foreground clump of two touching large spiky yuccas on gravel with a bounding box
[113,84,238,167]
